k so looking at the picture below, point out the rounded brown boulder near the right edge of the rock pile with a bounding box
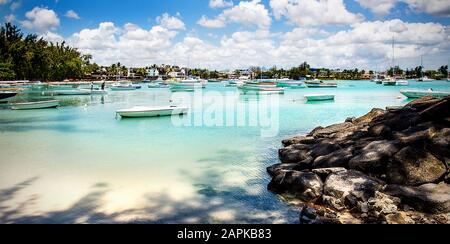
[387,147,447,185]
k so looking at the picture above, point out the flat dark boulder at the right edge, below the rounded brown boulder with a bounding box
[384,183,450,214]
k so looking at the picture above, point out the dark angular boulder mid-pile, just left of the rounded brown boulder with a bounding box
[348,140,400,174]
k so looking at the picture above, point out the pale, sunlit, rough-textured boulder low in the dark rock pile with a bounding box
[324,170,384,203]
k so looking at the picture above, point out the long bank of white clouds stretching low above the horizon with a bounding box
[55,16,450,69]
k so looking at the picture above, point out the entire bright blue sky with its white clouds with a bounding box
[0,0,450,69]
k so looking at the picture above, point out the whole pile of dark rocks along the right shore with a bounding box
[267,97,450,224]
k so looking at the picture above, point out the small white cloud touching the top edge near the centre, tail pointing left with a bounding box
[197,0,272,28]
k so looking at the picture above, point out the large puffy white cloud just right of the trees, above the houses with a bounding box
[68,22,177,66]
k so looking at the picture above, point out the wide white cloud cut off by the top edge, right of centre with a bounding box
[270,0,364,26]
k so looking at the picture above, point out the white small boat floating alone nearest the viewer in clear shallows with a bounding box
[116,106,189,118]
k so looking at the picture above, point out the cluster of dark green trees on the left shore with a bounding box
[0,23,96,81]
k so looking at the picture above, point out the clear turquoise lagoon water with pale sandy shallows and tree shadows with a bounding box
[0,81,450,223]
